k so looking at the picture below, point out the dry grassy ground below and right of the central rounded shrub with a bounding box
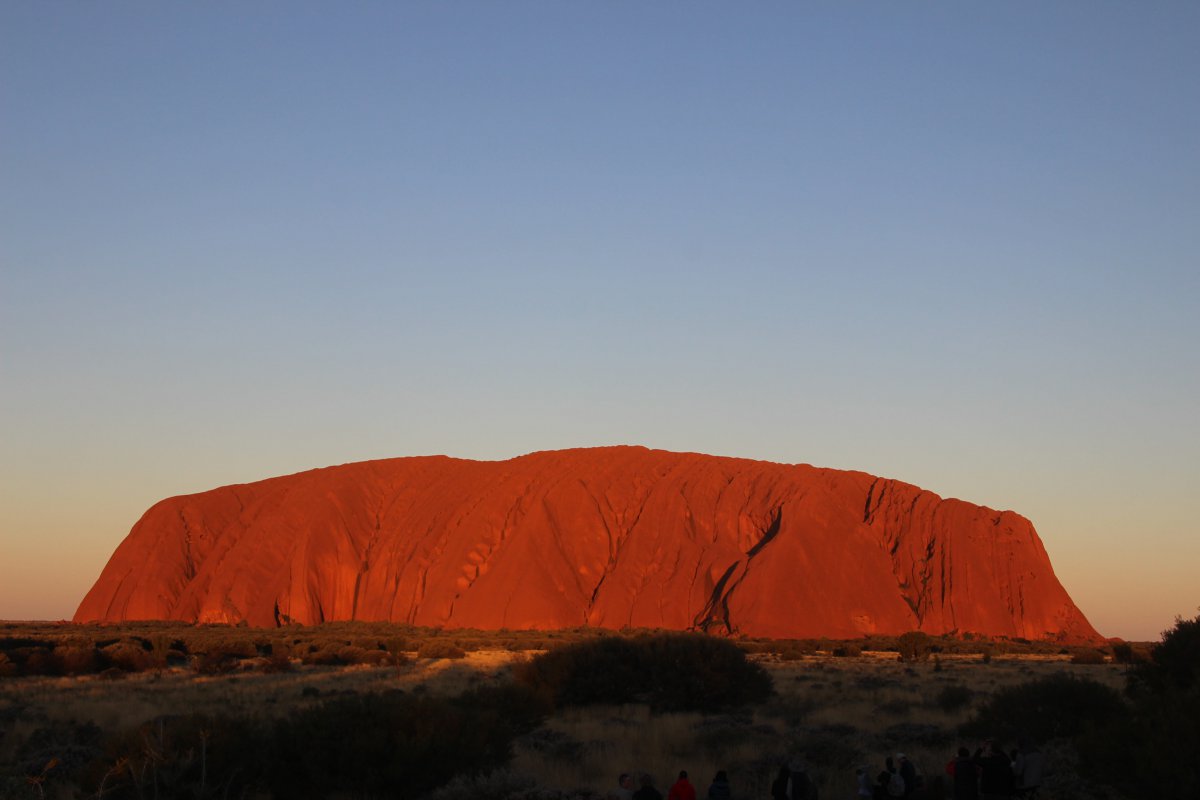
[512,652,1124,798]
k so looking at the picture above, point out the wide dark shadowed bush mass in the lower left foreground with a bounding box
[77,685,545,800]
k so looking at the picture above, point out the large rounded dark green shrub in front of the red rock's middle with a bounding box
[515,633,772,711]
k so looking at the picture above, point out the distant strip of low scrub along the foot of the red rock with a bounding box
[0,621,1150,678]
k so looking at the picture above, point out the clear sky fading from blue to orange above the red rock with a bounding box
[0,0,1200,639]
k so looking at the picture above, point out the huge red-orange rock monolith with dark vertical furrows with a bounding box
[74,447,1100,642]
